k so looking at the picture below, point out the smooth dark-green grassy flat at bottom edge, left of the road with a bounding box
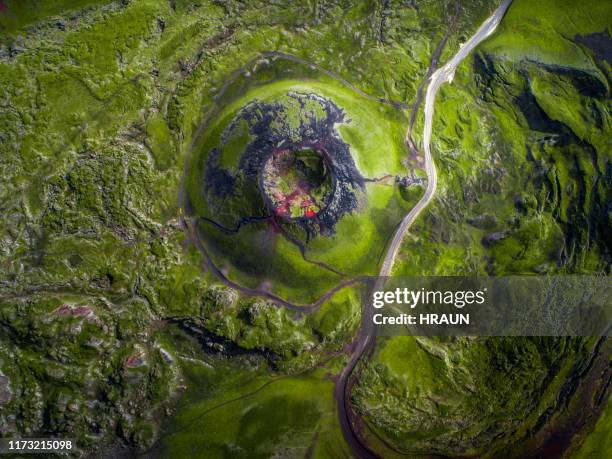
[153,324,350,457]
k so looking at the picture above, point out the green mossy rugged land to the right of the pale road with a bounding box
[354,0,610,457]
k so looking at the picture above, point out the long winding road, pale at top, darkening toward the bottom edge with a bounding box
[335,0,512,458]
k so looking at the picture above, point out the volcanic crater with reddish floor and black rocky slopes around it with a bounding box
[204,92,365,240]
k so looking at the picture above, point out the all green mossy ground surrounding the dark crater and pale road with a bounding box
[0,0,611,458]
